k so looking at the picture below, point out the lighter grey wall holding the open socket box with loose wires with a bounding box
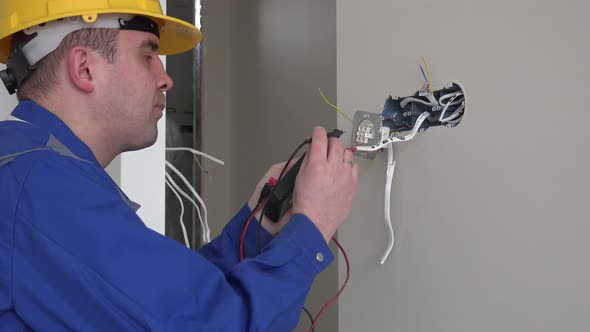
[337,0,590,332]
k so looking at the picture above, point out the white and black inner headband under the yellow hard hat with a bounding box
[0,14,160,94]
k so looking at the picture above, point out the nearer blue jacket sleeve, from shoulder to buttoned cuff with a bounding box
[12,157,333,331]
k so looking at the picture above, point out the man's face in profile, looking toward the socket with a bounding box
[102,31,173,151]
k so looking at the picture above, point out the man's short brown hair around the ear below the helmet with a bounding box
[16,29,119,101]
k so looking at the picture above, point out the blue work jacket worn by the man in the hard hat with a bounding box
[0,101,333,332]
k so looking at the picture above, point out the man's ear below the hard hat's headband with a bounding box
[66,46,98,93]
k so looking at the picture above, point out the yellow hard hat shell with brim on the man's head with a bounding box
[0,0,201,63]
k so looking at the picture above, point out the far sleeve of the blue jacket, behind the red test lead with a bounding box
[198,204,272,272]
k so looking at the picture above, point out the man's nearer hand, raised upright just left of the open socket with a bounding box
[292,127,359,242]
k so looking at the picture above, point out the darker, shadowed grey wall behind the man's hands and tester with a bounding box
[203,0,338,331]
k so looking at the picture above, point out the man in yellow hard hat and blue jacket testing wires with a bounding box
[0,0,358,331]
